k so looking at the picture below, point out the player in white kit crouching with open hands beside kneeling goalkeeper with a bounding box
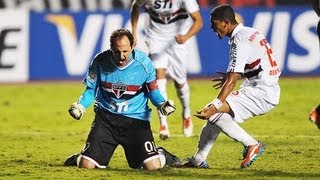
[183,4,281,168]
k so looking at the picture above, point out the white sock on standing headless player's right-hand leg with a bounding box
[176,82,190,118]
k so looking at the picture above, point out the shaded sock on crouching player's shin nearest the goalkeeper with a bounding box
[193,121,221,165]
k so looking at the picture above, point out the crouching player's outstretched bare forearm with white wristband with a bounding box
[195,72,241,119]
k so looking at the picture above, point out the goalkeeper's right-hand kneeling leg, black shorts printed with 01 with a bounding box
[119,115,180,170]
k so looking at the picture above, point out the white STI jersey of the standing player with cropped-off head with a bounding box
[136,0,199,38]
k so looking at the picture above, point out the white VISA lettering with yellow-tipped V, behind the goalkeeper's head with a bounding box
[46,13,201,76]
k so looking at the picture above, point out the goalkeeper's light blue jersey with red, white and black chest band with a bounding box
[79,50,165,121]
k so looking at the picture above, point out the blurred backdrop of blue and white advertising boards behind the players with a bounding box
[0,0,320,82]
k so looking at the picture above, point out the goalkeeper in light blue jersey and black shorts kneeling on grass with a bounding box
[65,29,179,170]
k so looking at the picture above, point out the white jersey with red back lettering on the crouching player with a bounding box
[227,24,281,86]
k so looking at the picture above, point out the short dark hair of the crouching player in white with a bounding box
[210,4,237,24]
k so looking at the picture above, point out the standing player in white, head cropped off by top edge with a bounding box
[131,0,203,139]
